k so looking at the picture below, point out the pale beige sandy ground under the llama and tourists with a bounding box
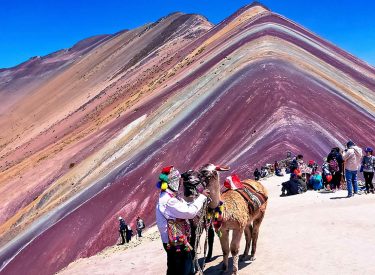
[59,177,375,275]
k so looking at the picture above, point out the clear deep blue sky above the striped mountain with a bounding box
[0,0,375,68]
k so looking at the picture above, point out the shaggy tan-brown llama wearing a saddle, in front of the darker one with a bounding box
[200,164,268,274]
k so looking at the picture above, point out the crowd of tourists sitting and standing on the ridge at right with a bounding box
[280,141,375,198]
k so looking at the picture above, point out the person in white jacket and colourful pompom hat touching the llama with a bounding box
[156,166,210,275]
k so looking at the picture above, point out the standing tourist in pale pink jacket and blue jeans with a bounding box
[343,140,362,198]
